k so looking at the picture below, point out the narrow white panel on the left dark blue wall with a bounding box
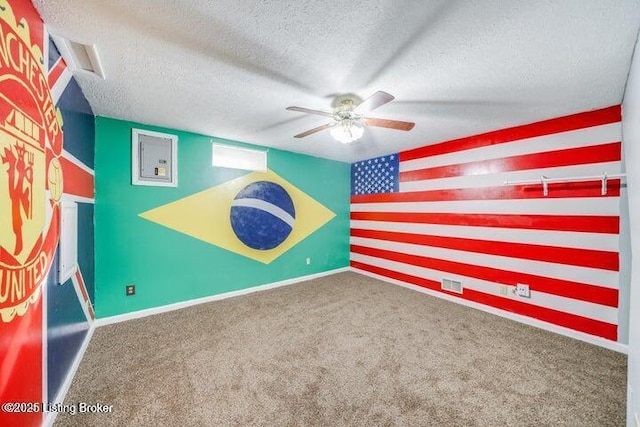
[58,199,78,284]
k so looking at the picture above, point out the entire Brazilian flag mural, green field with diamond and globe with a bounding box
[95,117,351,317]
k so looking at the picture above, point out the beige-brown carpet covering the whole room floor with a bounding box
[56,273,626,426]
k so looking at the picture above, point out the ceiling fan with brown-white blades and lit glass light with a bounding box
[287,91,415,144]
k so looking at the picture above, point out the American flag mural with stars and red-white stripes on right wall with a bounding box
[350,106,621,341]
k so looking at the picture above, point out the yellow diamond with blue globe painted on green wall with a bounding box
[140,171,336,264]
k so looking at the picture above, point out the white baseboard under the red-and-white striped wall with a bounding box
[351,267,629,354]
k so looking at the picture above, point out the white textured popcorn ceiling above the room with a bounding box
[34,0,640,162]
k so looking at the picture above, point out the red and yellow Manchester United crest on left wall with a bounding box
[0,0,62,322]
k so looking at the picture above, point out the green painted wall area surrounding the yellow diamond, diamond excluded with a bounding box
[95,117,350,317]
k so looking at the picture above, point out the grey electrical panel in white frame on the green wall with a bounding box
[131,129,178,187]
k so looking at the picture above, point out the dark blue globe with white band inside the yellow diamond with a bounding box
[230,181,296,250]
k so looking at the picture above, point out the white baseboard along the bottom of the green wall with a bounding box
[93,267,351,328]
